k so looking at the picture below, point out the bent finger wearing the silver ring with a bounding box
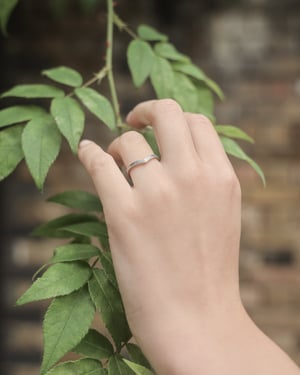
[108,131,161,186]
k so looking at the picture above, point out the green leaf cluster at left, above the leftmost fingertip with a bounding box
[0,66,115,189]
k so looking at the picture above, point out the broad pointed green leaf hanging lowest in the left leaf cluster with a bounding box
[22,115,61,189]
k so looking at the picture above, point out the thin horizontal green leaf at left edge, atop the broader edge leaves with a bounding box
[1,83,64,98]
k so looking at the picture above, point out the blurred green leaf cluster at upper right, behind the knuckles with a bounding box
[126,25,265,184]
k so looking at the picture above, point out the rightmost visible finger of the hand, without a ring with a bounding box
[185,113,231,166]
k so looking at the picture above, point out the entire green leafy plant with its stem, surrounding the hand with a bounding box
[0,0,265,375]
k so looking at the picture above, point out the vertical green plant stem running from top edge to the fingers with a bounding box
[106,0,122,128]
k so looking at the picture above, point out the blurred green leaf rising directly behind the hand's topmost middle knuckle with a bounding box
[173,72,198,112]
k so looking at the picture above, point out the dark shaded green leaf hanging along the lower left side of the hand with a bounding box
[89,269,131,349]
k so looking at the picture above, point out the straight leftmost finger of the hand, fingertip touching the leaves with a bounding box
[78,140,131,207]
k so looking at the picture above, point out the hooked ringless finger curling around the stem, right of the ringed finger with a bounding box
[127,99,195,164]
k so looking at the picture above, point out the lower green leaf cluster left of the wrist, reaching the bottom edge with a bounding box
[17,191,152,375]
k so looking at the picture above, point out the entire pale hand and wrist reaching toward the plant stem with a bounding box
[79,99,300,375]
